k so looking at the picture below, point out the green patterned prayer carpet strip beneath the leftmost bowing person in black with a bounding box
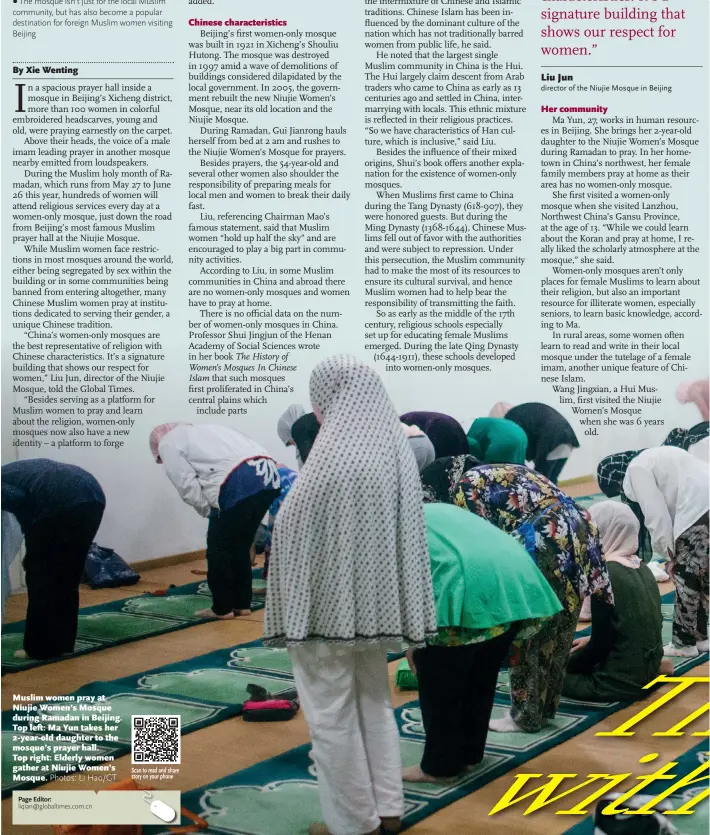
[2,568,266,675]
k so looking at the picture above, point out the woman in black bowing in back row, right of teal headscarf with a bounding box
[490,403,579,484]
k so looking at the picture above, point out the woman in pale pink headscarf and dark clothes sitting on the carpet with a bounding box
[562,502,673,702]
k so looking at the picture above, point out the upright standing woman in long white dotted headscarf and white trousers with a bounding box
[264,355,436,835]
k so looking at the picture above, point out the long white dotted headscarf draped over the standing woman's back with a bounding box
[264,355,436,646]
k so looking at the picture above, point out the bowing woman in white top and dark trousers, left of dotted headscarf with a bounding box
[150,423,280,620]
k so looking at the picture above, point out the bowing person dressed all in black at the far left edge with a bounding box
[2,458,106,661]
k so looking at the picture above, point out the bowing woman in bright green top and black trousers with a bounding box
[403,504,562,782]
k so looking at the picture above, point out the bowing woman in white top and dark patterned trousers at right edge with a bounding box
[597,446,710,658]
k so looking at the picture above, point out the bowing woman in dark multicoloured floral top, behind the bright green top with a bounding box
[453,464,613,733]
